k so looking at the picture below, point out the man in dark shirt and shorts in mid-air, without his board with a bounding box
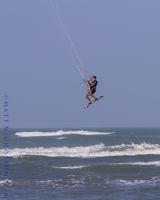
[84,76,98,105]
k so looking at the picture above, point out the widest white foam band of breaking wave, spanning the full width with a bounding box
[0,143,160,158]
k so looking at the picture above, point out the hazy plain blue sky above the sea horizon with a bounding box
[0,0,160,128]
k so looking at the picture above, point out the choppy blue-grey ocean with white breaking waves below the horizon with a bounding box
[0,128,160,200]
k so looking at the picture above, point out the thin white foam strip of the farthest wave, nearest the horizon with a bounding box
[15,130,114,137]
